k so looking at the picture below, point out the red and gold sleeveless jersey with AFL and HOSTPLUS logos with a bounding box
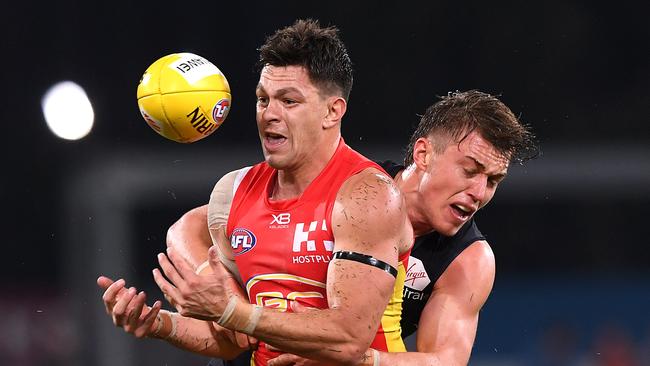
[227,139,408,365]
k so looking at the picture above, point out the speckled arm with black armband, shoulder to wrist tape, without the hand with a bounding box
[246,170,412,365]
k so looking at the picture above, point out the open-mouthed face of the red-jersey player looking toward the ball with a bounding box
[255,66,327,170]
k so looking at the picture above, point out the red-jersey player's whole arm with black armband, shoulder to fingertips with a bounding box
[154,170,412,365]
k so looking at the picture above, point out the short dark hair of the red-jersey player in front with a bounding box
[257,19,352,100]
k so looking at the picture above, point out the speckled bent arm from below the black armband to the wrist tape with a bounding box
[235,261,394,365]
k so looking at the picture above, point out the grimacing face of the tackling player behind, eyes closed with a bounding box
[419,132,509,236]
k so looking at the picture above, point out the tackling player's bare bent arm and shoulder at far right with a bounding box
[372,241,495,366]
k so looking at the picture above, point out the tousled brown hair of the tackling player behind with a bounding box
[404,90,539,166]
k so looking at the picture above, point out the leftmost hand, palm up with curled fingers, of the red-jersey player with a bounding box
[97,276,162,338]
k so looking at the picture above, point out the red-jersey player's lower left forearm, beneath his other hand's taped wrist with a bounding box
[151,311,244,359]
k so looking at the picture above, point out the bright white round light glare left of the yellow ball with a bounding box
[41,81,95,140]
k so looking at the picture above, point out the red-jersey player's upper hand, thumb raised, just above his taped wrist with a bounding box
[153,248,242,321]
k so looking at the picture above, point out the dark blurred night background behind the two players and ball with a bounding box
[0,0,650,365]
